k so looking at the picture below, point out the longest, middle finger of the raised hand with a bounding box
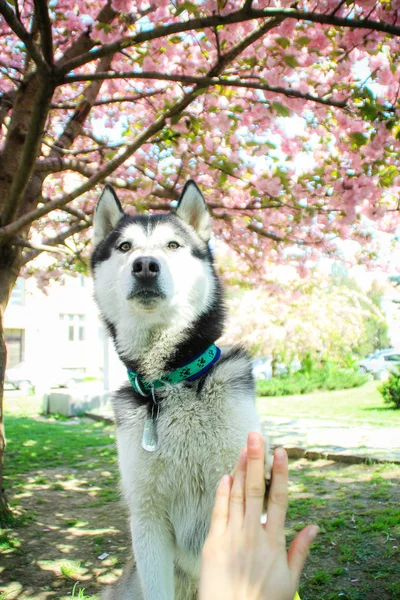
[245,432,265,527]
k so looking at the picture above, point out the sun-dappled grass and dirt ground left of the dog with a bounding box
[0,416,129,600]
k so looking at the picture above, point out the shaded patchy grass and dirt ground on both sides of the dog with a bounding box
[0,398,400,600]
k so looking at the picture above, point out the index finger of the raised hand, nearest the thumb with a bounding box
[265,448,288,538]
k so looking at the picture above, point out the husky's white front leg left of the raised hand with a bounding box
[131,518,174,600]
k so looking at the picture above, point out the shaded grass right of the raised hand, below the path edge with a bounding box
[288,461,400,600]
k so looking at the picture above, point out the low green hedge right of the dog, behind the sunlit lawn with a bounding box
[256,363,368,396]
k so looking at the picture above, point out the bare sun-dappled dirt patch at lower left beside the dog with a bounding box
[0,468,129,600]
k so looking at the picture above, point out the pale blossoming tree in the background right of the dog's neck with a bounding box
[223,277,386,364]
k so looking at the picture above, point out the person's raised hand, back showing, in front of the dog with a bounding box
[199,432,318,600]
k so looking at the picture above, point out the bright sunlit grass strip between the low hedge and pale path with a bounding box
[257,382,400,427]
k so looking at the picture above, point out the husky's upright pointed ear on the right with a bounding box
[176,179,211,242]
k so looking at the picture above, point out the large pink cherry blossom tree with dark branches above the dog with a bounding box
[0,0,400,508]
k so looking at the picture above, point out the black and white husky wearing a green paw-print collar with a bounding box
[91,181,270,600]
